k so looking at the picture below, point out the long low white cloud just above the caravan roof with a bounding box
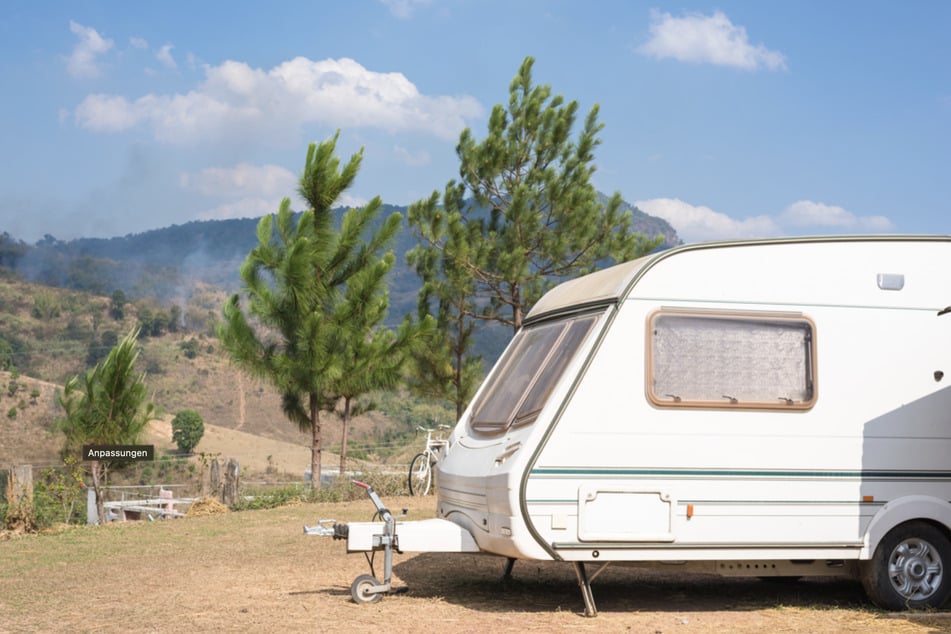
[634,198,894,242]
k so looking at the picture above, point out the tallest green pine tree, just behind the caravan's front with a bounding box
[408,57,664,415]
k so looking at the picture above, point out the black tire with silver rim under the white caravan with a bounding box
[860,522,951,611]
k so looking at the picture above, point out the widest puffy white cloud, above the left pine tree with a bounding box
[76,57,483,145]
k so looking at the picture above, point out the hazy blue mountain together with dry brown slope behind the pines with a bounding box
[0,198,680,469]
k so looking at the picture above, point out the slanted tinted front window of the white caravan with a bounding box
[472,315,598,432]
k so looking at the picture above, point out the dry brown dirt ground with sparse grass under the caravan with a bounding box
[0,496,951,634]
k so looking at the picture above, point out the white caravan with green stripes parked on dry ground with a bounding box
[330,237,951,615]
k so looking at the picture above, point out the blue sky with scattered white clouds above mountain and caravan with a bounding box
[0,0,951,243]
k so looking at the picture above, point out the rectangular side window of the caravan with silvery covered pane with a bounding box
[647,311,816,409]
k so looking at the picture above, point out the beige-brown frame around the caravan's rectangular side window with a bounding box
[644,308,819,412]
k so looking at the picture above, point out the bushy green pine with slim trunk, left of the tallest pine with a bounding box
[218,133,422,486]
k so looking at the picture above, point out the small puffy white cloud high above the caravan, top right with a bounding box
[638,11,786,70]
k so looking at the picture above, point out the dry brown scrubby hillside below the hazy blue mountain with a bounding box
[0,275,438,476]
